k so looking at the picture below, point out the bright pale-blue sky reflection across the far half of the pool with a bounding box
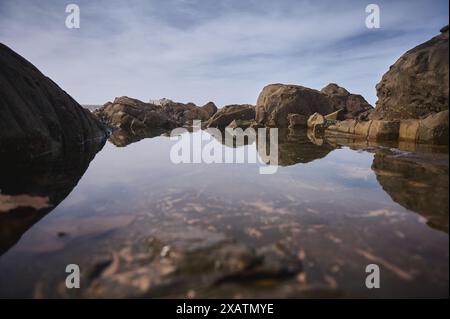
[11,137,414,240]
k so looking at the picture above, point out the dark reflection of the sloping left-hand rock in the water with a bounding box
[0,141,104,255]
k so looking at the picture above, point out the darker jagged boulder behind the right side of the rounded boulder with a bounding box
[320,83,373,120]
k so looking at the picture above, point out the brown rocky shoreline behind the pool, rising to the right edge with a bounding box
[90,27,449,145]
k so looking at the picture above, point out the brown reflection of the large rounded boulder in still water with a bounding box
[258,129,335,166]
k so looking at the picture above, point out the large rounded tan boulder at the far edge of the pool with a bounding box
[256,84,334,127]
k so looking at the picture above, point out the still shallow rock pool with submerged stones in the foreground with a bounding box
[0,129,449,298]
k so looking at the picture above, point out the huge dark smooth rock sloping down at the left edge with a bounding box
[0,43,107,161]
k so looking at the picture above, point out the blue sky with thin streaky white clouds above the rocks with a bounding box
[0,0,448,106]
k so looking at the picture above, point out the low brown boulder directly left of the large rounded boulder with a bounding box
[206,104,255,128]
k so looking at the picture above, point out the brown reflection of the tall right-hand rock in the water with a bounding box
[372,151,449,232]
